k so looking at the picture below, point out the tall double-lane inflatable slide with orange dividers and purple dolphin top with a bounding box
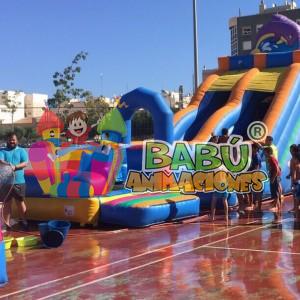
[174,15,300,192]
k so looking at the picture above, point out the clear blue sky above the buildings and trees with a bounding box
[0,0,268,97]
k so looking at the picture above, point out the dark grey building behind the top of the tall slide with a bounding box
[229,0,300,56]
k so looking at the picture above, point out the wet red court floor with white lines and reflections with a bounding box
[0,196,300,300]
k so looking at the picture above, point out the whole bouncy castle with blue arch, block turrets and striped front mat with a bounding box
[14,88,204,227]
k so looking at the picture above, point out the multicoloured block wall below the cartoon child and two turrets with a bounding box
[29,141,123,198]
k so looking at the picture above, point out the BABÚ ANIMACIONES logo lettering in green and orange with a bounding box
[125,136,268,193]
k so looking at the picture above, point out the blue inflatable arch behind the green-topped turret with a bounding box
[118,87,173,144]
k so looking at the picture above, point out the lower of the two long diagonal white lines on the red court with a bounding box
[39,219,293,300]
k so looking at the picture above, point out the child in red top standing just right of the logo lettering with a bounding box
[264,147,282,212]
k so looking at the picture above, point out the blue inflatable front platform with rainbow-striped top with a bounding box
[100,192,200,227]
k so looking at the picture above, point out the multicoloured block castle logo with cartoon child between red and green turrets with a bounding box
[29,109,126,198]
